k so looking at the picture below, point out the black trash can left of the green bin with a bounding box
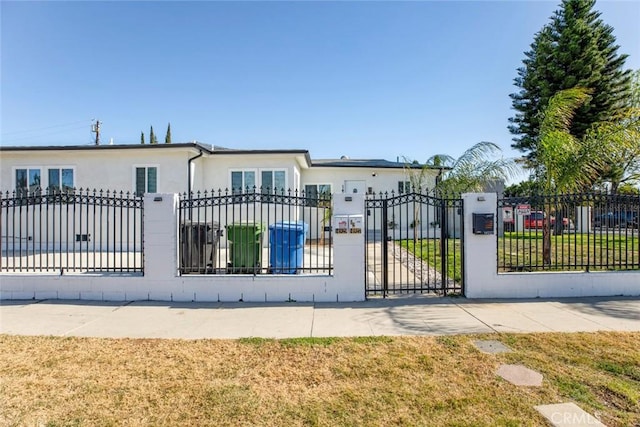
[180,222,220,274]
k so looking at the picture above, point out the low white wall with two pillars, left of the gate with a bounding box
[0,194,365,302]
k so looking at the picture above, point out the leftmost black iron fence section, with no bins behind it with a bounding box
[0,189,144,274]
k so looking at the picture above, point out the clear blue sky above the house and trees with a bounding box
[0,0,640,161]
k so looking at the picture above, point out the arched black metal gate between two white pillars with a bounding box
[365,193,464,297]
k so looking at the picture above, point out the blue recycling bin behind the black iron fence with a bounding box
[269,221,309,274]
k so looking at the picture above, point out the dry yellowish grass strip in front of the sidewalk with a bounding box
[0,333,640,426]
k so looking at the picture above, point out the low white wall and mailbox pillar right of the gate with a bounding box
[462,193,640,298]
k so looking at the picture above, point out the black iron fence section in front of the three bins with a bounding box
[178,187,333,275]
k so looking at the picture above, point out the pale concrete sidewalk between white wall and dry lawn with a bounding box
[0,296,640,339]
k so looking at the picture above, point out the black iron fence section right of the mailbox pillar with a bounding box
[497,193,640,272]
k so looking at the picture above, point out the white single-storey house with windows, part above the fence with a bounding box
[0,142,439,198]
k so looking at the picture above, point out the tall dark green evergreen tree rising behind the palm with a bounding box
[509,0,630,165]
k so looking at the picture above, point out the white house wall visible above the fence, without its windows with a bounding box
[0,145,435,193]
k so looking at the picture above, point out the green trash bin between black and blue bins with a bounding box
[226,223,265,274]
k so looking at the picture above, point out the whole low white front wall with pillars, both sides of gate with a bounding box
[0,193,640,302]
